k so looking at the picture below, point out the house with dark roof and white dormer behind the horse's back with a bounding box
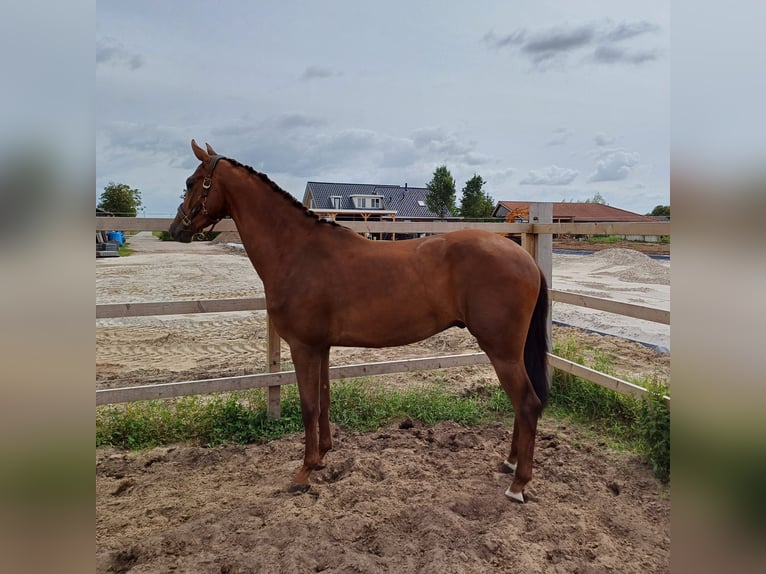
[303,181,455,239]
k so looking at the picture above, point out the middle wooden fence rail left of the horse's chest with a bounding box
[96,297,266,319]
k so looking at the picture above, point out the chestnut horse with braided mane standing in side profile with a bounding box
[169,140,549,502]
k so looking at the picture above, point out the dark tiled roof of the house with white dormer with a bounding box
[303,181,438,219]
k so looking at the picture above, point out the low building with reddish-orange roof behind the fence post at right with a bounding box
[492,201,659,241]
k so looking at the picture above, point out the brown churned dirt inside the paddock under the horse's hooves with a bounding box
[96,421,670,574]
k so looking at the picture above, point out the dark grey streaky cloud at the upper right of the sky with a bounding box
[482,20,660,69]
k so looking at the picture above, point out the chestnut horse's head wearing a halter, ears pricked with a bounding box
[169,140,228,243]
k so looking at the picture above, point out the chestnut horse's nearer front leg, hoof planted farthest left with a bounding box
[289,345,329,492]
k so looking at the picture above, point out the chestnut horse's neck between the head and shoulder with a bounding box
[227,174,319,290]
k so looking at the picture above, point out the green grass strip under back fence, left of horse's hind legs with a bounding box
[96,379,484,449]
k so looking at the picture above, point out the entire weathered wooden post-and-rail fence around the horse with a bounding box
[96,213,670,416]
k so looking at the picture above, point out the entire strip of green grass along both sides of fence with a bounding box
[96,339,670,480]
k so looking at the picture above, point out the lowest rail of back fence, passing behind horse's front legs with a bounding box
[96,353,489,405]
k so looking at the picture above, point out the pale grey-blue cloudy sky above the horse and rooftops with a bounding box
[94,0,670,217]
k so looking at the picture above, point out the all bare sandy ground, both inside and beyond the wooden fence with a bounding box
[96,234,670,573]
